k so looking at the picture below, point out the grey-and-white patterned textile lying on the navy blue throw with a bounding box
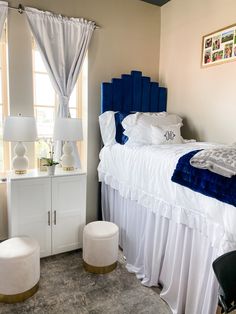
[190,146,236,178]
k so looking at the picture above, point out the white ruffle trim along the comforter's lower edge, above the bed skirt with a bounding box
[99,171,236,254]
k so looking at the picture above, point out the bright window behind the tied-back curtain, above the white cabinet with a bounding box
[33,42,87,167]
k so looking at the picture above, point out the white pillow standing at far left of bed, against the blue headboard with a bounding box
[99,111,116,146]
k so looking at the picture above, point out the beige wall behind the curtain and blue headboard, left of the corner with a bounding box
[1,0,160,228]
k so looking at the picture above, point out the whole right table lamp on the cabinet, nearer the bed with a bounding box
[53,118,83,171]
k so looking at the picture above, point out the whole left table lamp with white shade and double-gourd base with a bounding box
[3,115,37,174]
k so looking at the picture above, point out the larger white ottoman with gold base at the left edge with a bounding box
[0,237,40,303]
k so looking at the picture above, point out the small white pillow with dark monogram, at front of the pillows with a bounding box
[151,123,183,145]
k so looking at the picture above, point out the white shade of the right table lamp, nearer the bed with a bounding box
[53,118,83,141]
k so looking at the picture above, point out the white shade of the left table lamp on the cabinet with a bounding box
[3,116,37,142]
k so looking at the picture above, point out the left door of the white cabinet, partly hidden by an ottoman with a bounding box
[8,178,51,257]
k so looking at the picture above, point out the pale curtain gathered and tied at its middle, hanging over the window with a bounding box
[25,7,96,167]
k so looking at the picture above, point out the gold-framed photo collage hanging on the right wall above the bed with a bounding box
[201,24,236,67]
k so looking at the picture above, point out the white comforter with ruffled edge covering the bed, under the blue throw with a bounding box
[98,143,236,252]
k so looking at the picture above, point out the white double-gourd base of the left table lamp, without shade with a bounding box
[12,142,29,174]
